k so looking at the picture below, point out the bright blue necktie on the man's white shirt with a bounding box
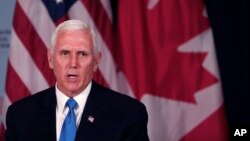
[59,98,77,141]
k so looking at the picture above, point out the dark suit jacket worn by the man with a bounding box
[6,81,149,141]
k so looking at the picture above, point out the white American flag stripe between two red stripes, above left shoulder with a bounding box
[9,30,49,93]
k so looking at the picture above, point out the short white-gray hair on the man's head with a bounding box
[51,20,100,54]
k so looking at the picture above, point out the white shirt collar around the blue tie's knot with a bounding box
[56,81,92,113]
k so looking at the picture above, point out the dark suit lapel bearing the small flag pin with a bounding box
[76,81,102,141]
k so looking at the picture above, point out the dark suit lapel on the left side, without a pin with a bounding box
[37,87,56,141]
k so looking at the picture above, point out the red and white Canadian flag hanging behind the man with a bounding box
[115,0,227,141]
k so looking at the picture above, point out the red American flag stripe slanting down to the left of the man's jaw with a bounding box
[13,2,54,85]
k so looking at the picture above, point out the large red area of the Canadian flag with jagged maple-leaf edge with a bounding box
[116,0,218,103]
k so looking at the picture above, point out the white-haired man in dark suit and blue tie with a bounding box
[6,20,149,141]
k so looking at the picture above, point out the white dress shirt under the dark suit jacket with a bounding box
[56,82,92,141]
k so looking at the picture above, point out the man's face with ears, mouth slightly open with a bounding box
[48,30,100,97]
